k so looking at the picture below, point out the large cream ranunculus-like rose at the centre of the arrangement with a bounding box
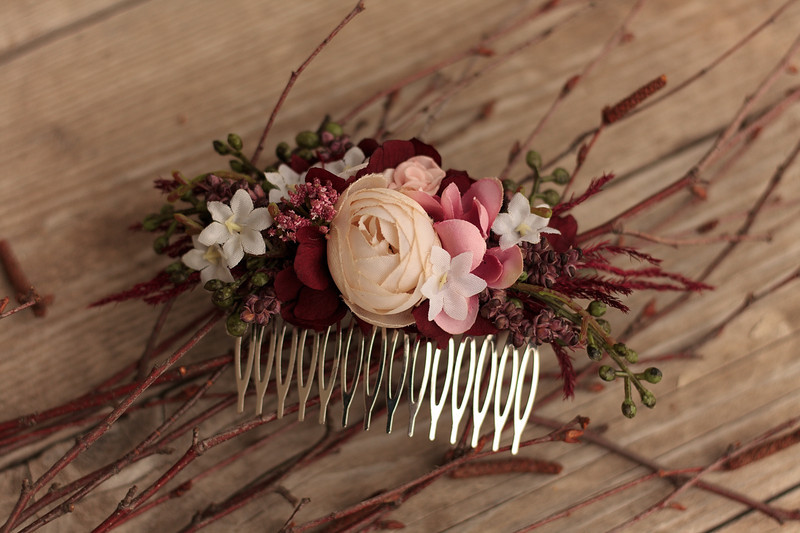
[327,174,439,328]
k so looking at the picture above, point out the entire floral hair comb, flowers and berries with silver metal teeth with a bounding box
[90,120,698,453]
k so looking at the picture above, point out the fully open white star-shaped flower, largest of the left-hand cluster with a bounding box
[197,189,272,268]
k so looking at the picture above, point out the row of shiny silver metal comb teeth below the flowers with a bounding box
[234,320,539,454]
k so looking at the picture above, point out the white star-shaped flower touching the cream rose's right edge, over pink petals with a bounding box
[420,246,486,320]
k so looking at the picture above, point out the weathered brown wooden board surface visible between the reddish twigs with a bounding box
[0,0,800,532]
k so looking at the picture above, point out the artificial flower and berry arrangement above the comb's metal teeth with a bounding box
[96,119,705,417]
